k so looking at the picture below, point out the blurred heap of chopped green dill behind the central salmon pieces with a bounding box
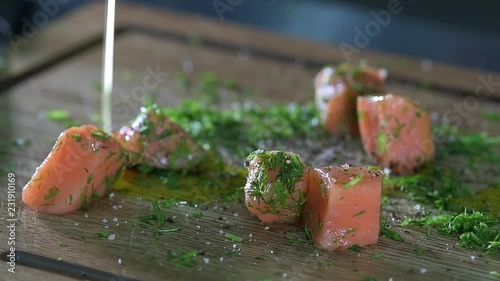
[162,100,324,158]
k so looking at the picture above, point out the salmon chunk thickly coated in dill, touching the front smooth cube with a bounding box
[245,150,309,223]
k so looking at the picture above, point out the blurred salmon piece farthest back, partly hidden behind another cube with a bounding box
[315,64,387,136]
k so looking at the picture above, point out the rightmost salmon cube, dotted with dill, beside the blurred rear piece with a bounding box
[358,94,434,175]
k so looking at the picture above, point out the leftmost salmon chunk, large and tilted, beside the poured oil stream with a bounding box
[22,125,127,214]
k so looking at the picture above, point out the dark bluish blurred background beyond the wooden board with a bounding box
[0,0,500,72]
